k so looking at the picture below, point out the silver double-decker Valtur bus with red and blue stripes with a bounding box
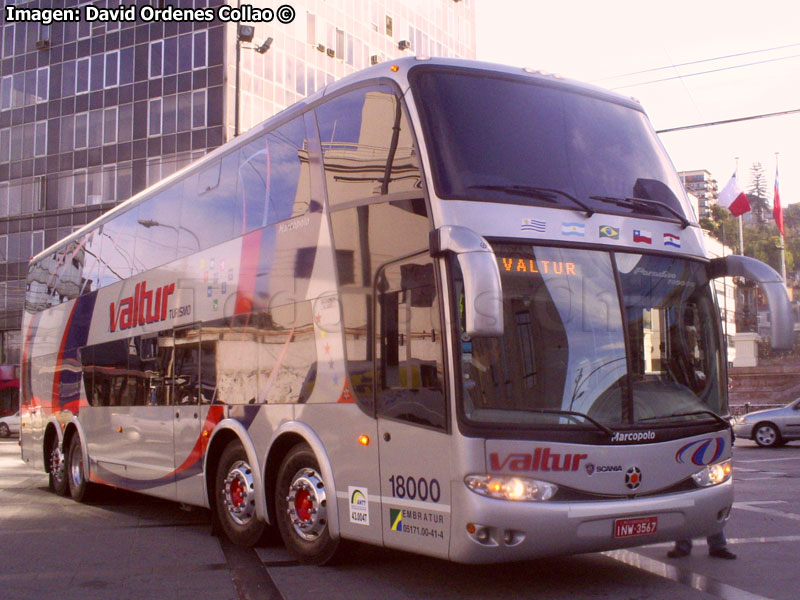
[21,58,793,563]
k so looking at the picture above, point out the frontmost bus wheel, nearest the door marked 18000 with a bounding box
[275,444,339,565]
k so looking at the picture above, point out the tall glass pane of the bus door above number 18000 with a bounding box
[375,255,447,429]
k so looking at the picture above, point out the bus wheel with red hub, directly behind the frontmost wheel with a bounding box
[214,442,266,546]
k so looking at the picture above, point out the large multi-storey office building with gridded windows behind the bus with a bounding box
[0,0,475,372]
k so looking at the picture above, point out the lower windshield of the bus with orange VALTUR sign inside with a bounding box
[461,244,727,429]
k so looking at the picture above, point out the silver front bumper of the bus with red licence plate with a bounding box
[450,480,733,563]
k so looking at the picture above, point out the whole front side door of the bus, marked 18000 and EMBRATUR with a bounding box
[375,254,452,558]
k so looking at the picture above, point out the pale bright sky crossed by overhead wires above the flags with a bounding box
[473,0,800,206]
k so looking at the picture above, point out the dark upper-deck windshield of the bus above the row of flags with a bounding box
[411,67,695,226]
